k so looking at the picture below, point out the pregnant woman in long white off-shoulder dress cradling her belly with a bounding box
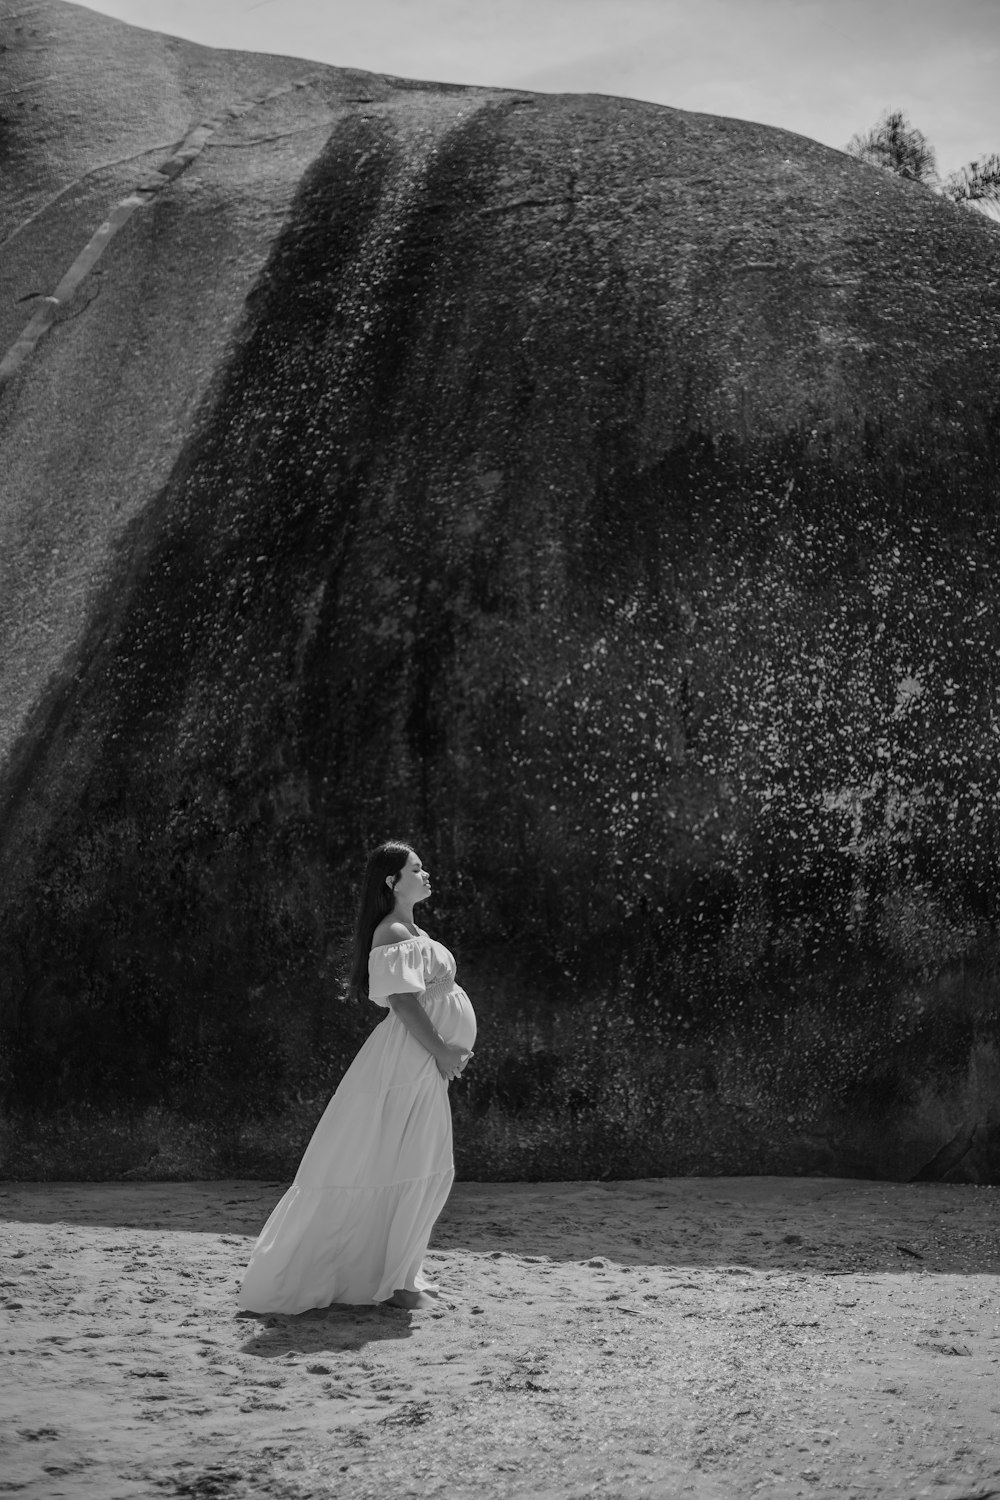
[238,843,475,1313]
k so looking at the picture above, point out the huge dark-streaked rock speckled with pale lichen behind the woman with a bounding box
[0,0,1000,1179]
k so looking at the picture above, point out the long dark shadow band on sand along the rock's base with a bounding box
[0,1178,1000,1278]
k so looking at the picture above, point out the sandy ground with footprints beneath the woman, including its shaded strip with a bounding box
[0,1178,1000,1500]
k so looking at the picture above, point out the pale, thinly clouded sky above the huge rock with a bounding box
[82,0,1000,174]
